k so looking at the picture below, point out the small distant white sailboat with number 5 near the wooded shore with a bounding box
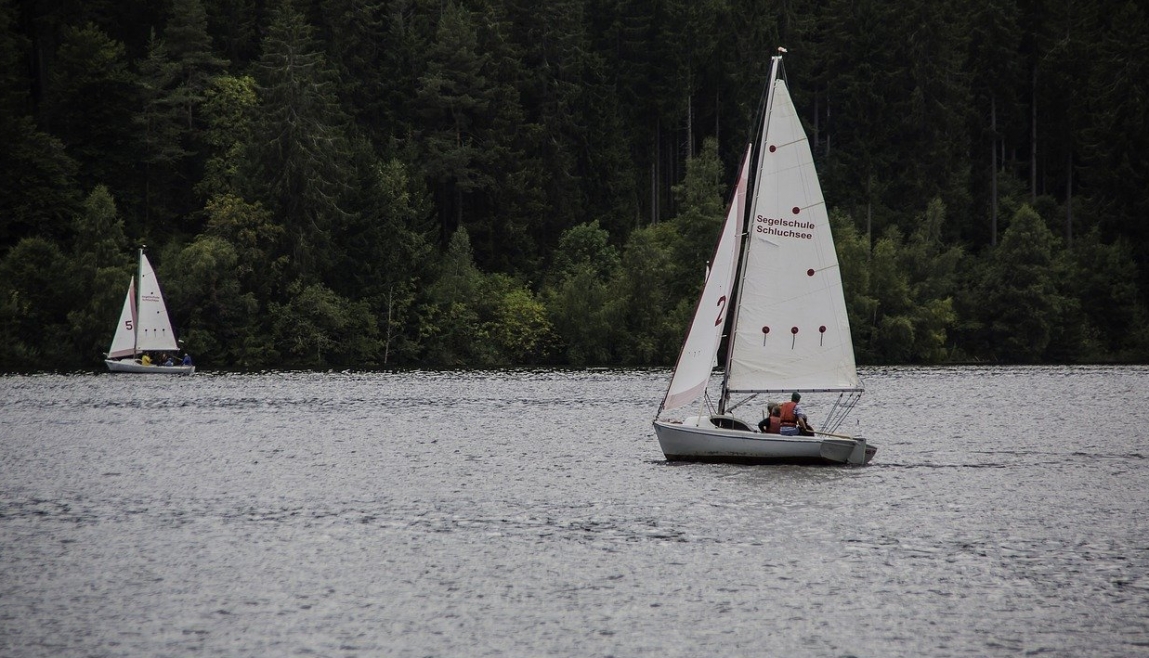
[103,248,195,374]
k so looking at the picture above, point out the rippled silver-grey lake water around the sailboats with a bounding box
[0,367,1149,658]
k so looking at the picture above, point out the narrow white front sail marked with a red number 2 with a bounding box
[663,149,750,410]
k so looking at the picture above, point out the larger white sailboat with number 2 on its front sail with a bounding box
[654,48,877,465]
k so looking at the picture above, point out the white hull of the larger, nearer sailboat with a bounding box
[654,418,877,465]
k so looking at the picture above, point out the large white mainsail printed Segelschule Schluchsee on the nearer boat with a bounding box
[726,79,861,393]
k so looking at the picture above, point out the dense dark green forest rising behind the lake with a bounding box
[0,0,1149,370]
